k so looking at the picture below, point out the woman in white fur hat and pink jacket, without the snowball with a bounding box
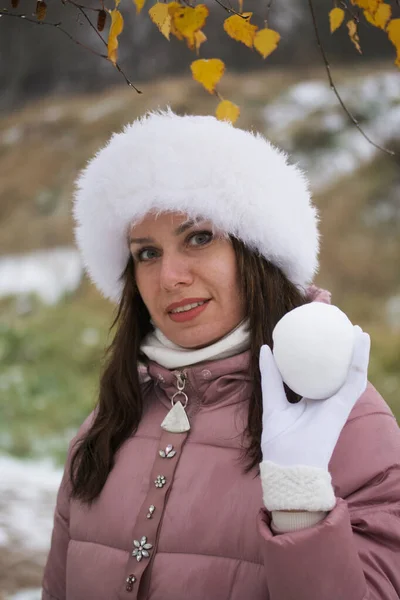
[43,111,400,600]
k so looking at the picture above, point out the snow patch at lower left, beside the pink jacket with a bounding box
[0,456,62,553]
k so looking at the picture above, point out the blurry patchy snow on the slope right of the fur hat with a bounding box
[263,72,400,190]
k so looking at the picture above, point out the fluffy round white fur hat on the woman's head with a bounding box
[73,109,319,302]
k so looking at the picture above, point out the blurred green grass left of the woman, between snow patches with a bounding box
[0,282,112,462]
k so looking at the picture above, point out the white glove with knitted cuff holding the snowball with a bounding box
[260,326,370,511]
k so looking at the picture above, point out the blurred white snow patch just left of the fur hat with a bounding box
[0,247,83,304]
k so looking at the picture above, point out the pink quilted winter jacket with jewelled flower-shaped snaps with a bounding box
[42,351,400,600]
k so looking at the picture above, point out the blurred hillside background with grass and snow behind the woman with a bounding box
[0,0,400,600]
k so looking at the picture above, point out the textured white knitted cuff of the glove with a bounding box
[260,460,336,511]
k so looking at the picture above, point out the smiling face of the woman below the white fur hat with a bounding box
[129,213,245,348]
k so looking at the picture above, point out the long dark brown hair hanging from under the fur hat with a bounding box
[69,236,309,504]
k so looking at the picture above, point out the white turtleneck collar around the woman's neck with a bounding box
[140,319,250,369]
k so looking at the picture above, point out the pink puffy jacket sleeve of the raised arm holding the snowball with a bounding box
[258,386,400,600]
